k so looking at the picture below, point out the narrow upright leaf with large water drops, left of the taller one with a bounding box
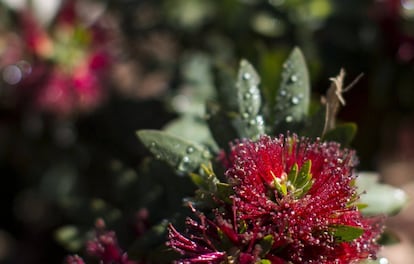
[236,60,265,139]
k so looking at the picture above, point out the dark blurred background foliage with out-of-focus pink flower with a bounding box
[0,0,414,263]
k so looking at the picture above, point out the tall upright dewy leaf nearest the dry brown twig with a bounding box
[274,48,310,130]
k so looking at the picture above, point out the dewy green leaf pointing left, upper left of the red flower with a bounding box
[137,130,211,174]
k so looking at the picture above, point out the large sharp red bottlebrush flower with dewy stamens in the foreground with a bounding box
[167,136,382,264]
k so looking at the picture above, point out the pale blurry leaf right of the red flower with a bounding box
[356,172,408,215]
